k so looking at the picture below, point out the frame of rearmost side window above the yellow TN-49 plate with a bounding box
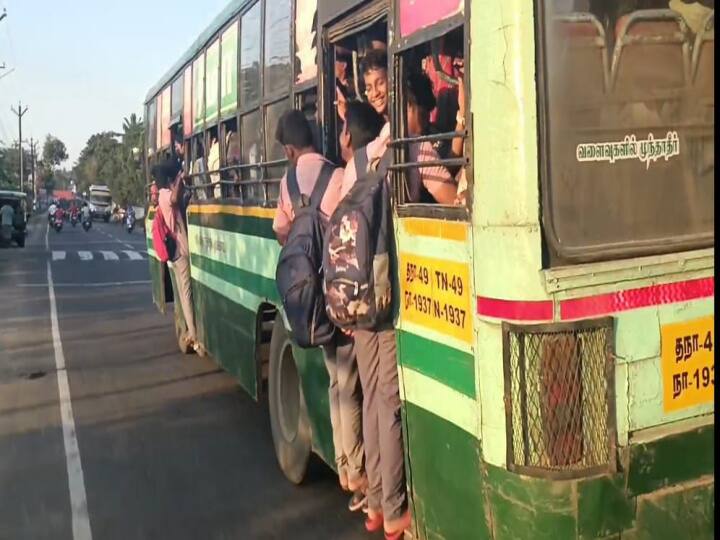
[388,0,475,222]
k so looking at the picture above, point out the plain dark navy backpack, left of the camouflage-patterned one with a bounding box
[275,163,335,348]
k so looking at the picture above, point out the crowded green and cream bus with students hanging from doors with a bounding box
[145,0,715,540]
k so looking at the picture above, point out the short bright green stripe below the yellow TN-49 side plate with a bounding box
[398,330,477,399]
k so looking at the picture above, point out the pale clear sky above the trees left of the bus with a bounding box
[0,0,228,168]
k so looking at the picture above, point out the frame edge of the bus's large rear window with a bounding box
[533,0,715,270]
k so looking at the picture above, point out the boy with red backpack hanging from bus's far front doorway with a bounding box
[153,158,202,354]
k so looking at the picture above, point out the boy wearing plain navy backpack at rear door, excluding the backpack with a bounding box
[273,110,367,511]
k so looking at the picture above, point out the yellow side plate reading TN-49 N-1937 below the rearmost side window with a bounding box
[400,254,472,343]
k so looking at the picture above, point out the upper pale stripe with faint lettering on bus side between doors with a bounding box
[189,225,280,280]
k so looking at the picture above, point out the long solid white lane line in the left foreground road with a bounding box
[47,261,92,540]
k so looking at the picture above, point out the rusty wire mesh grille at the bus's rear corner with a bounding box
[503,319,615,477]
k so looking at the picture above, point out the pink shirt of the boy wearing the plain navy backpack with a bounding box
[273,152,343,237]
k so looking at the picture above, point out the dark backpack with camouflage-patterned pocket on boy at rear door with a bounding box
[323,148,392,330]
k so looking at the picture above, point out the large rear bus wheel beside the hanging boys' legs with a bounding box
[268,313,312,484]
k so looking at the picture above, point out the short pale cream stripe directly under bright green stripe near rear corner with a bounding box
[398,367,480,440]
